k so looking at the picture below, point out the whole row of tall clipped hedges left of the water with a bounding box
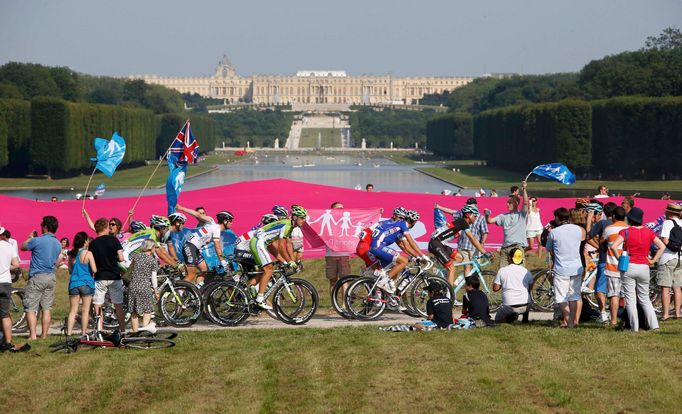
[0,97,215,176]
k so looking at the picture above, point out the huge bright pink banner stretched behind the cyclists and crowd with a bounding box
[0,179,668,260]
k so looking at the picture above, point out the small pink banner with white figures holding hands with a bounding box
[306,208,381,253]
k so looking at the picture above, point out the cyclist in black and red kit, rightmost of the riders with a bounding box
[429,204,486,286]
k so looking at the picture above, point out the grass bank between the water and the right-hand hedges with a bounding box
[418,160,682,193]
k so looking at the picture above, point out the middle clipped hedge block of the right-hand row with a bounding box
[474,100,592,172]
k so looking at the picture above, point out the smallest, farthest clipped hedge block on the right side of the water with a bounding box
[426,112,474,158]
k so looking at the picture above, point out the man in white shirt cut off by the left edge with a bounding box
[0,227,31,352]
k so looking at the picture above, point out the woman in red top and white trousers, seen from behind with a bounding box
[615,207,665,332]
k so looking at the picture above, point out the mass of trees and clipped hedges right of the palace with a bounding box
[427,29,682,179]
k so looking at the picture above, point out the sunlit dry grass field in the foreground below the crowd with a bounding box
[5,259,682,413]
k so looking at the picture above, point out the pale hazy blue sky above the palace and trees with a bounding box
[0,0,682,76]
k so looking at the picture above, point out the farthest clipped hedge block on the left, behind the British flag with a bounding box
[156,114,217,158]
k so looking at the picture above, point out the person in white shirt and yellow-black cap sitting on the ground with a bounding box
[493,247,533,323]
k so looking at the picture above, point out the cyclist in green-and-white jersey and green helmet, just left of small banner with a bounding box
[249,205,308,310]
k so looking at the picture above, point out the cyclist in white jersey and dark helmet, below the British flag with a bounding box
[175,204,234,286]
